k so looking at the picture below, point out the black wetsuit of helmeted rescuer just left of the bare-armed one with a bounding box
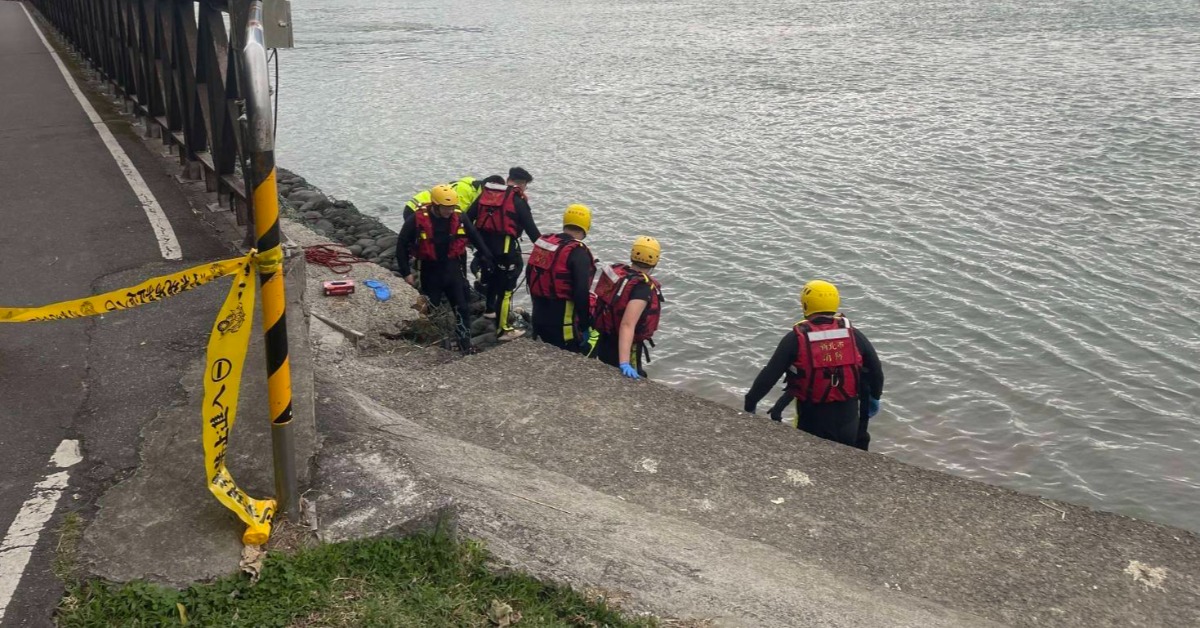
[526,233,595,352]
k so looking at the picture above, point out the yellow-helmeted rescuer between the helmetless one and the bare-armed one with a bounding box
[526,205,595,353]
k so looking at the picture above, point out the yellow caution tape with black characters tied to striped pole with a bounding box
[0,251,278,545]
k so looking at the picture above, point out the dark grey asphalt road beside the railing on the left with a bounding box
[0,1,230,627]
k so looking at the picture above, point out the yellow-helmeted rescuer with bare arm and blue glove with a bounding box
[592,235,664,379]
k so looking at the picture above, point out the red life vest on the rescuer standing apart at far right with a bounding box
[787,316,863,403]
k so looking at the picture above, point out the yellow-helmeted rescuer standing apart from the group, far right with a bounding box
[745,280,883,449]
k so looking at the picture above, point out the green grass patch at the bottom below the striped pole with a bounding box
[56,534,656,628]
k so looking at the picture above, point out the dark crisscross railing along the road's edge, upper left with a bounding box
[31,0,248,225]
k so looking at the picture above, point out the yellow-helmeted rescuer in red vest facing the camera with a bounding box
[396,185,492,353]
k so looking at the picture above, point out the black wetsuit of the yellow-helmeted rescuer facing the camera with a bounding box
[396,211,492,349]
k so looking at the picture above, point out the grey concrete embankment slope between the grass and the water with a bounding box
[317,331,1200,626]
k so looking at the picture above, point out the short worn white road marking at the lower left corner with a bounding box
[0,441,83,622]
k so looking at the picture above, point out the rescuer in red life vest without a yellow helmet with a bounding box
[467,168,541,340]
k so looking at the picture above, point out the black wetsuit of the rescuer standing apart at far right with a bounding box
[745,317,883,449]
